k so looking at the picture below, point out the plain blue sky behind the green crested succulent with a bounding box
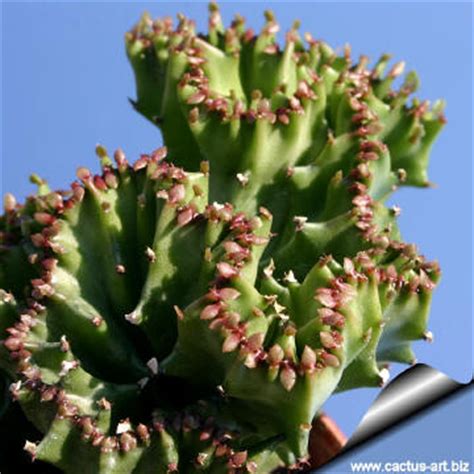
[1,2,472,444]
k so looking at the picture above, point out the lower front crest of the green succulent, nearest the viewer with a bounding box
[0,149,438,472]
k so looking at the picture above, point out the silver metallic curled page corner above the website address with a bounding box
[311,364,473,472]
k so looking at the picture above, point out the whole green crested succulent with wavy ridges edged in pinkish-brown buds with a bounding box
[0,5,444,473]
